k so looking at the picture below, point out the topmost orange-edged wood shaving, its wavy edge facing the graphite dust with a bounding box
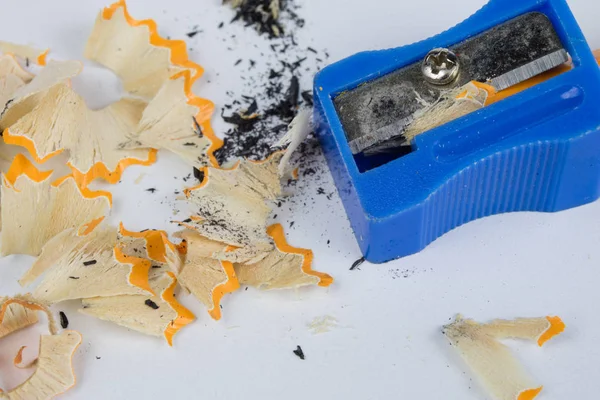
[85,0,223,167]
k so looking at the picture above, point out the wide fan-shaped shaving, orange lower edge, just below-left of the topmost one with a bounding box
[4,83,156,187]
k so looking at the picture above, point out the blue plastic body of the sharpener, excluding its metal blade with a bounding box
[314,0,600,263]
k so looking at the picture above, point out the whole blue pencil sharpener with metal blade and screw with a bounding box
[314,0,600,263]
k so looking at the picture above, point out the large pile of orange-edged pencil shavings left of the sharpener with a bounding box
[0,1,333,399]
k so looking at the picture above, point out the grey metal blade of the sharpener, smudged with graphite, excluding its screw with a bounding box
[334,12,569,155]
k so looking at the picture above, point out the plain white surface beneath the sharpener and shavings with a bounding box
[0,0,600,400]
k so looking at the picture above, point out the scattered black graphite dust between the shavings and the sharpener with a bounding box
[216,0,328,164]
